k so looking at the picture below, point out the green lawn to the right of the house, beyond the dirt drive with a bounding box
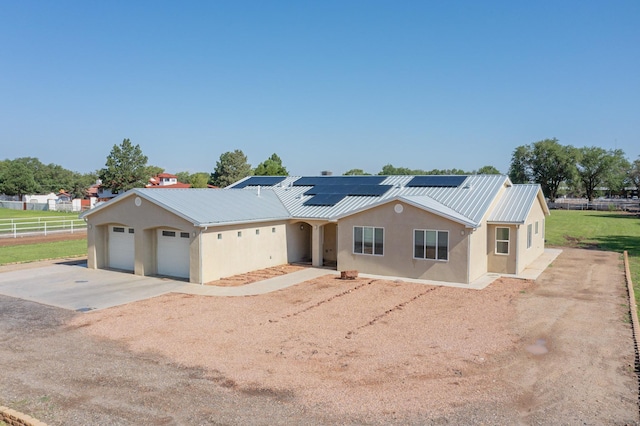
[545,210,640,300]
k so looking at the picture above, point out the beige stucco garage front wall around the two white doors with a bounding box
[87,196,198,282]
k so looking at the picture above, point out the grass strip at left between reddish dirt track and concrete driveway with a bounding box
[0,238,87,265]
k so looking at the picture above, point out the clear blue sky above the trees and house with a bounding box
[0,0,640,175]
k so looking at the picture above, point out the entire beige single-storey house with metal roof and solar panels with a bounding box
[82,175,549,283]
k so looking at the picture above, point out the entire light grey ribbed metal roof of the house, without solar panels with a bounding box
[82,175,536,231]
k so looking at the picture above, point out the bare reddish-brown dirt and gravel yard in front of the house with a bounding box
[0,249,639,425]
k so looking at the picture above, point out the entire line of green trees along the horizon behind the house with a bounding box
[0,139,640,201]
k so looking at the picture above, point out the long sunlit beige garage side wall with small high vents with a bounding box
[200,222,290,283]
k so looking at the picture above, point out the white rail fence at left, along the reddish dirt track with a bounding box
[0,216,87,238]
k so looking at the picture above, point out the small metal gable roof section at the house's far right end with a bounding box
[487,184,549,224]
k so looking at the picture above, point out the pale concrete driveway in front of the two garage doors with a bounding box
[0,262,188,312]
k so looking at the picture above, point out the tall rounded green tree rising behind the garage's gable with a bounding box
[99,139,148,193]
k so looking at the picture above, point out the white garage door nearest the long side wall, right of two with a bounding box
[157,229,190,278]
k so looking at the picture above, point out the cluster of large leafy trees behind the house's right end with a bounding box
[509,138,640,201]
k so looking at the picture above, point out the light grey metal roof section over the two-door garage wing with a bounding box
[81,188,290,227]
